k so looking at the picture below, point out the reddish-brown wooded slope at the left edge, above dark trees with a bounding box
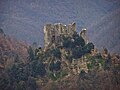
[0,33,28,62]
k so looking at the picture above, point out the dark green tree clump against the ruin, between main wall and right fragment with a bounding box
[63,32,94,61]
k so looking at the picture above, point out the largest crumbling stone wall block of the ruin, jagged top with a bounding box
[44,23,76,48]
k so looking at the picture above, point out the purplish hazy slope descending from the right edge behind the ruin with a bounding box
[88,8,120,53]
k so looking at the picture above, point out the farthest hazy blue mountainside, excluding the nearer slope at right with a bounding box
[0,0,120,49]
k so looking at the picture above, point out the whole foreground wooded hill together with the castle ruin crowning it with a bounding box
[0,23,120,90]
